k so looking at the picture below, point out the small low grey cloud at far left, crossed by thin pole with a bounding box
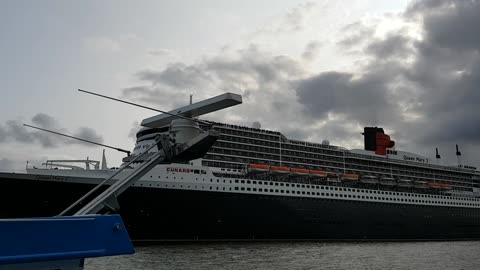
[0,113,103,148]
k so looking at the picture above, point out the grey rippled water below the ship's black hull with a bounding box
[86,241,480,270]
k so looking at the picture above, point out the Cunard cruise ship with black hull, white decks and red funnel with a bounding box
[0,93,480,241]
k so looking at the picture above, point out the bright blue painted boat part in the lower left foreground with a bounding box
[0,215,134,270]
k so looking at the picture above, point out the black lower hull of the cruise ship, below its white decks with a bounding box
[0,174,480,240]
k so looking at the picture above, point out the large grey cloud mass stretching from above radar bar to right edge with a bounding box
[123,0,480,166]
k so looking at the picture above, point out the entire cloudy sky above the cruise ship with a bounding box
[0,0,480,171]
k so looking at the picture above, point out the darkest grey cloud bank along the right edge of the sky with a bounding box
[400,1,480,151]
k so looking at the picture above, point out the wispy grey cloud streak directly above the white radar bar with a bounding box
[122,45,303,112]
